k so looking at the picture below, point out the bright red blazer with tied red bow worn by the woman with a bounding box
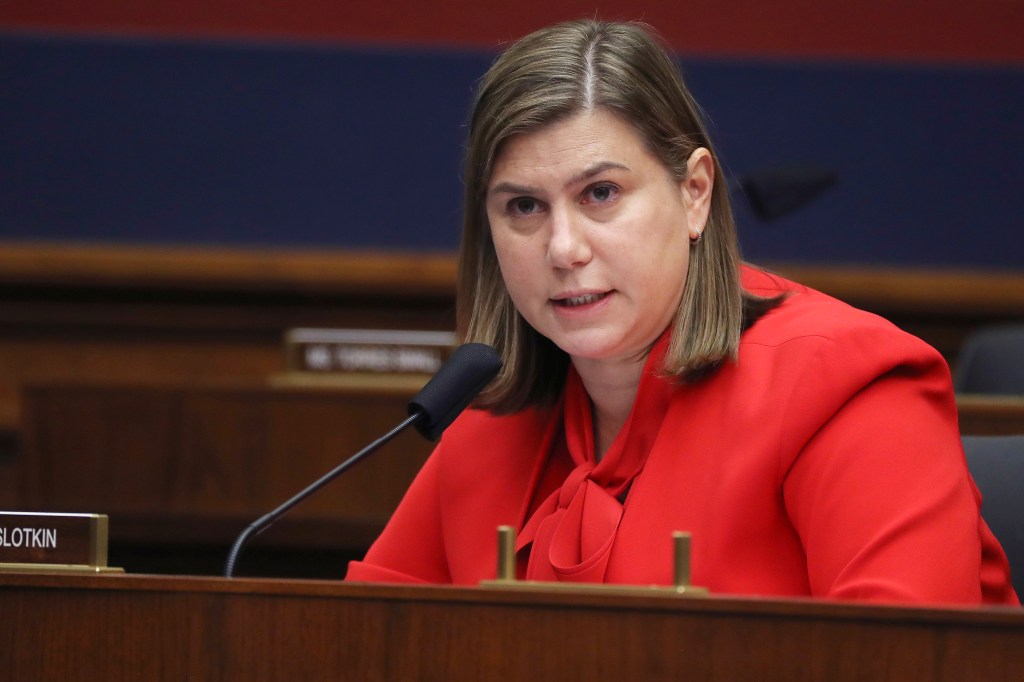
[347,268,1019,604]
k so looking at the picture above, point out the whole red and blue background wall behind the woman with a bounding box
[0,0,1024,270]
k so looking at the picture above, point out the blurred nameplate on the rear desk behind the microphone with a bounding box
[285,329,456,375]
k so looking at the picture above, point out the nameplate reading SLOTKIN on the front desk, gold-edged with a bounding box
[0,512,122,572]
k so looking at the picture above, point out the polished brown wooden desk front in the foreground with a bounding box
[0,574,1024,682]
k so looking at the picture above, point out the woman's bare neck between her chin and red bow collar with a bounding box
[572,357,646,460]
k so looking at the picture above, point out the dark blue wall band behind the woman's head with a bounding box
[0,34,1024,269]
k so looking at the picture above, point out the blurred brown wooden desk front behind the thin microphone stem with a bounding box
[16,379,433,550]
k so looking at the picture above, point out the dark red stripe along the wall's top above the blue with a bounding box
[0,0,1024,65]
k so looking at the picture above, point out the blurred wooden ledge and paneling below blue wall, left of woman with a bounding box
[0,245,455,432]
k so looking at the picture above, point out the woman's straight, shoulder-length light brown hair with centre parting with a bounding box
[457,20,764,413]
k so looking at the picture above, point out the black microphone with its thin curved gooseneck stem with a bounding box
[224,343,502,578]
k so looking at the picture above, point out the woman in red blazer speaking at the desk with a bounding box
[347,22,1018,603]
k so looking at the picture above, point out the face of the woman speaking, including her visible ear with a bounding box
[486,109,714,364]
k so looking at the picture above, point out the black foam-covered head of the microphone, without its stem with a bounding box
[409,343,503,440]
